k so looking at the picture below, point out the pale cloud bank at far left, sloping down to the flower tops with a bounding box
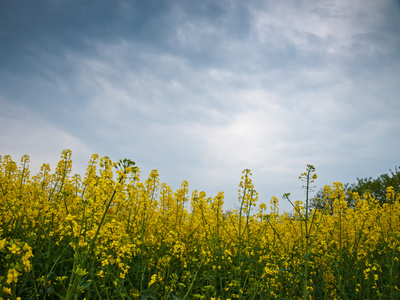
[0,98,94,176]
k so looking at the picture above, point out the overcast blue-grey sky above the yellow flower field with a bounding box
[0,0,400,211]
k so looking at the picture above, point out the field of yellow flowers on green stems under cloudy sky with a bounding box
[0,150,400,299]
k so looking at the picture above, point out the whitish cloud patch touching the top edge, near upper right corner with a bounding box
[253,0,385,55]
